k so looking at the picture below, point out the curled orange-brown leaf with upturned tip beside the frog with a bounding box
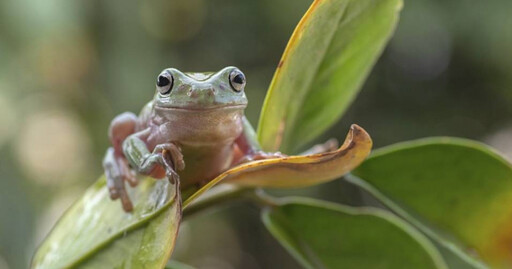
[183,124,372,208]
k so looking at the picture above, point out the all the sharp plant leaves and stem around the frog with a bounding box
[32,0,512,268]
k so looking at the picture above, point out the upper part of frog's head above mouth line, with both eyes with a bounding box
[154,66,247,110]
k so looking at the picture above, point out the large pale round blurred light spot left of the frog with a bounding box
[16,108,90,184]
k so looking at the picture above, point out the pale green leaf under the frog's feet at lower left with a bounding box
[32,177,181,269]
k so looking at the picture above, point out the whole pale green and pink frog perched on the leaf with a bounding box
[103,66,337,212]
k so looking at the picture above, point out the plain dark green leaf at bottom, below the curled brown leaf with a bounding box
[262,196,446,269]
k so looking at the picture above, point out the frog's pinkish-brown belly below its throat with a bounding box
[178,144,234,188]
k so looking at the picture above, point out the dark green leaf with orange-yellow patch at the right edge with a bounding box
[354,138,512,268]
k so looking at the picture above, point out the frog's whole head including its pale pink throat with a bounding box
[152,67,247,145]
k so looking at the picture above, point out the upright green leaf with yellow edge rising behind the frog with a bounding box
[258,0,402,153]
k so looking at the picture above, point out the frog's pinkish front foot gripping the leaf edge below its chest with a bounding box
[153,143,185,184]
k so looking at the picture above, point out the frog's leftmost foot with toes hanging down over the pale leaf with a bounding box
[103,148,138,212]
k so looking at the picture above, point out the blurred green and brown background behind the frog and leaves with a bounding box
[0,0,512,269]
